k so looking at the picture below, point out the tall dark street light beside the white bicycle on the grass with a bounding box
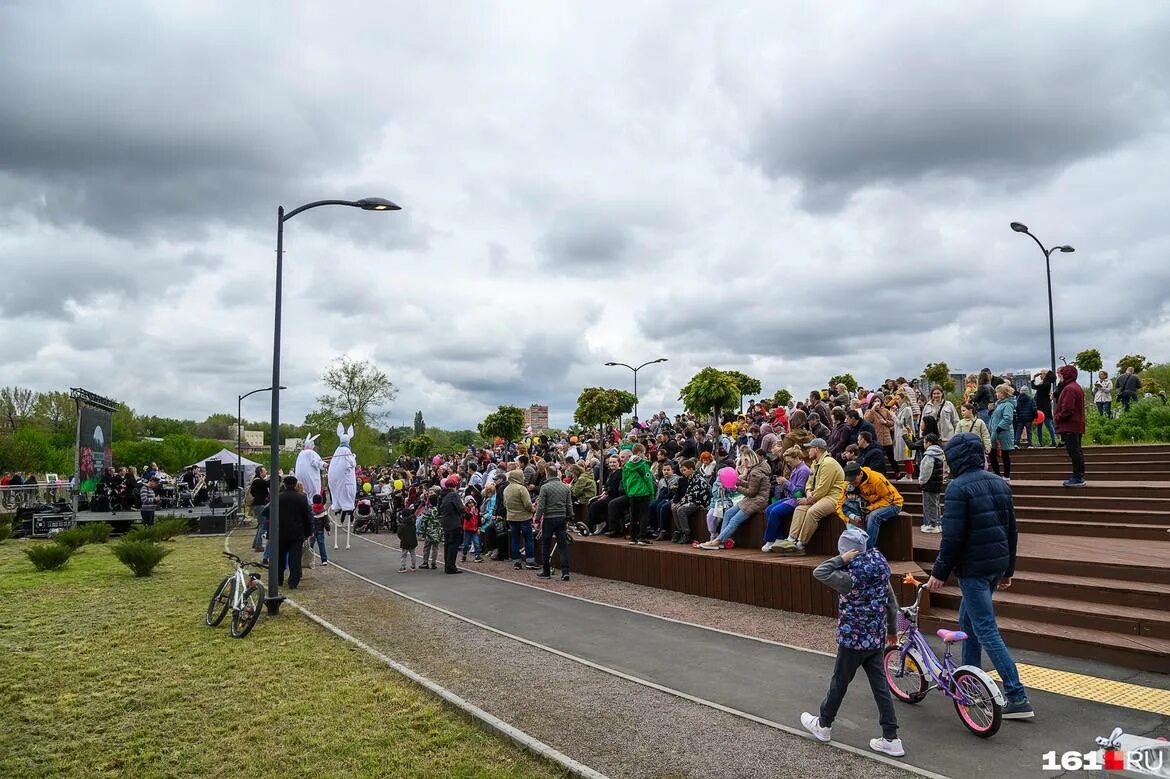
[264,198,401,615]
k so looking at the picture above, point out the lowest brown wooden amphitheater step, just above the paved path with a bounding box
[921,597,1170,674]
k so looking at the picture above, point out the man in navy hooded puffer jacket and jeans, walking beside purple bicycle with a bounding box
[927,430,1034,719]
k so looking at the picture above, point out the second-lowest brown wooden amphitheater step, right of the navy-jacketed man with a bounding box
[930,581,1170,639]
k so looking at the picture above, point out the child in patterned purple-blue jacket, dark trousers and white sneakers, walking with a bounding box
[800,525,906,757]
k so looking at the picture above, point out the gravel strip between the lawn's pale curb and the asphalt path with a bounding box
[232,537,913,779]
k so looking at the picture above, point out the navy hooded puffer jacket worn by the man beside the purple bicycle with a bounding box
[930,433,1017,581]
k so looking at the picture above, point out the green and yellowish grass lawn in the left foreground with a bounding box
[0,538,563,779]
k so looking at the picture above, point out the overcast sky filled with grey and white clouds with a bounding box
[0,0,1170,427]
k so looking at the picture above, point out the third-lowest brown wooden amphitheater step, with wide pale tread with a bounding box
[914,528,1170,585]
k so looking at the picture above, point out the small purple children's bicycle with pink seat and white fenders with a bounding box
[885,580,1004,738]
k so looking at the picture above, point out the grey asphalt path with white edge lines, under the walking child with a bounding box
[329,537,1170,778]
